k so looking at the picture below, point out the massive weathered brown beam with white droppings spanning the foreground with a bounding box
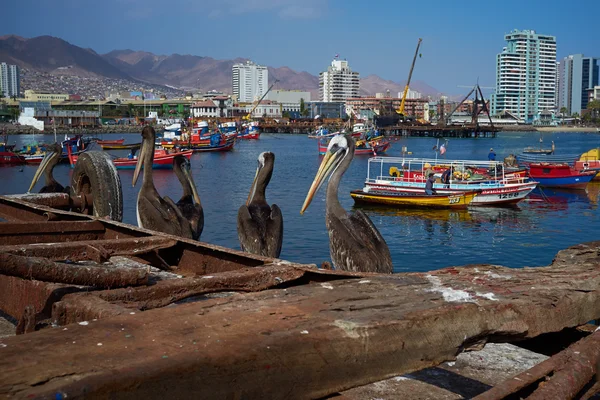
[0,243,600,399]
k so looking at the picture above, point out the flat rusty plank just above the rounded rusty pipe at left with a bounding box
[0,236,177,262]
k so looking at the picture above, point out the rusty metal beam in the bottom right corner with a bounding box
[473,331,600,400]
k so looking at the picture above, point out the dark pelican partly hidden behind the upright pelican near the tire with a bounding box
[173,155,204,240]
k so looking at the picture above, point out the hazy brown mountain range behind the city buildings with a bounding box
[0,35,438,99]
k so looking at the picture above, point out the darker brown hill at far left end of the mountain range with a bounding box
[0,35,129,79]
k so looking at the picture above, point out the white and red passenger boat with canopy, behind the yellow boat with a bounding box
[363,157,537,206]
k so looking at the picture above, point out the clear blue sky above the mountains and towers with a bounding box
[0,0,600,94]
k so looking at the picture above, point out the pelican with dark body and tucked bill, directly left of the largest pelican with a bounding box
[238,151,283,258]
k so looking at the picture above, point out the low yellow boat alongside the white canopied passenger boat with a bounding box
[350,190,478,208]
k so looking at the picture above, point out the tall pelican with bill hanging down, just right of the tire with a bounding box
[133,126,192,239]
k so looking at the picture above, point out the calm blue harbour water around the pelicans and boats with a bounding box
[0,132,600,272]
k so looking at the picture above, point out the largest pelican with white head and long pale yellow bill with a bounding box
[300,135,392,273]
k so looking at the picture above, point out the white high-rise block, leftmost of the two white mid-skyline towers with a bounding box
[232,61,269,103]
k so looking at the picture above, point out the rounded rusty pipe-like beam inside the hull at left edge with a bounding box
[0,253,148,288]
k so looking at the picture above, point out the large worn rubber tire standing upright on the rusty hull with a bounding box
[71,151,123,222]
